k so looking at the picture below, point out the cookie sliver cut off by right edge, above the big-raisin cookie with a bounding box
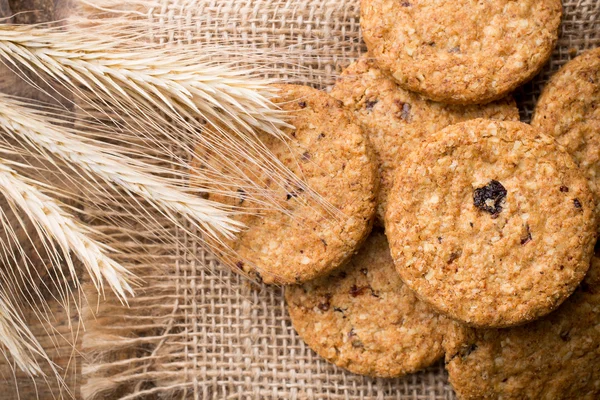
[531,48,600,212]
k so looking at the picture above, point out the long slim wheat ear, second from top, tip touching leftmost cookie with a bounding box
[0,94,242,240]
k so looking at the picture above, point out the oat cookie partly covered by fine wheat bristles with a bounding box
[192,85,378,284]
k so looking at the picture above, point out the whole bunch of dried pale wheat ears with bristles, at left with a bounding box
[0,14,321,386]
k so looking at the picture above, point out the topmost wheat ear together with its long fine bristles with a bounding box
[0,20,324,212]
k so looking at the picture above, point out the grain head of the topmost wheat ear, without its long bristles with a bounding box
[0,22,286,140]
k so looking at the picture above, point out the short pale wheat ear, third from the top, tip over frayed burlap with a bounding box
[0,163,133,301]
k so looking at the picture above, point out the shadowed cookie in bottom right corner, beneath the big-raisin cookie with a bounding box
[446,244,600,400]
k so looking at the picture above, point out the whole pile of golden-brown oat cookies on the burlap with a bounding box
[195,0,600,399]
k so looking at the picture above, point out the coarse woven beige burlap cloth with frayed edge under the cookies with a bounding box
[2,0,600,400]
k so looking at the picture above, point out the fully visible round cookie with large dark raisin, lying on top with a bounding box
[385,119,596,327]
